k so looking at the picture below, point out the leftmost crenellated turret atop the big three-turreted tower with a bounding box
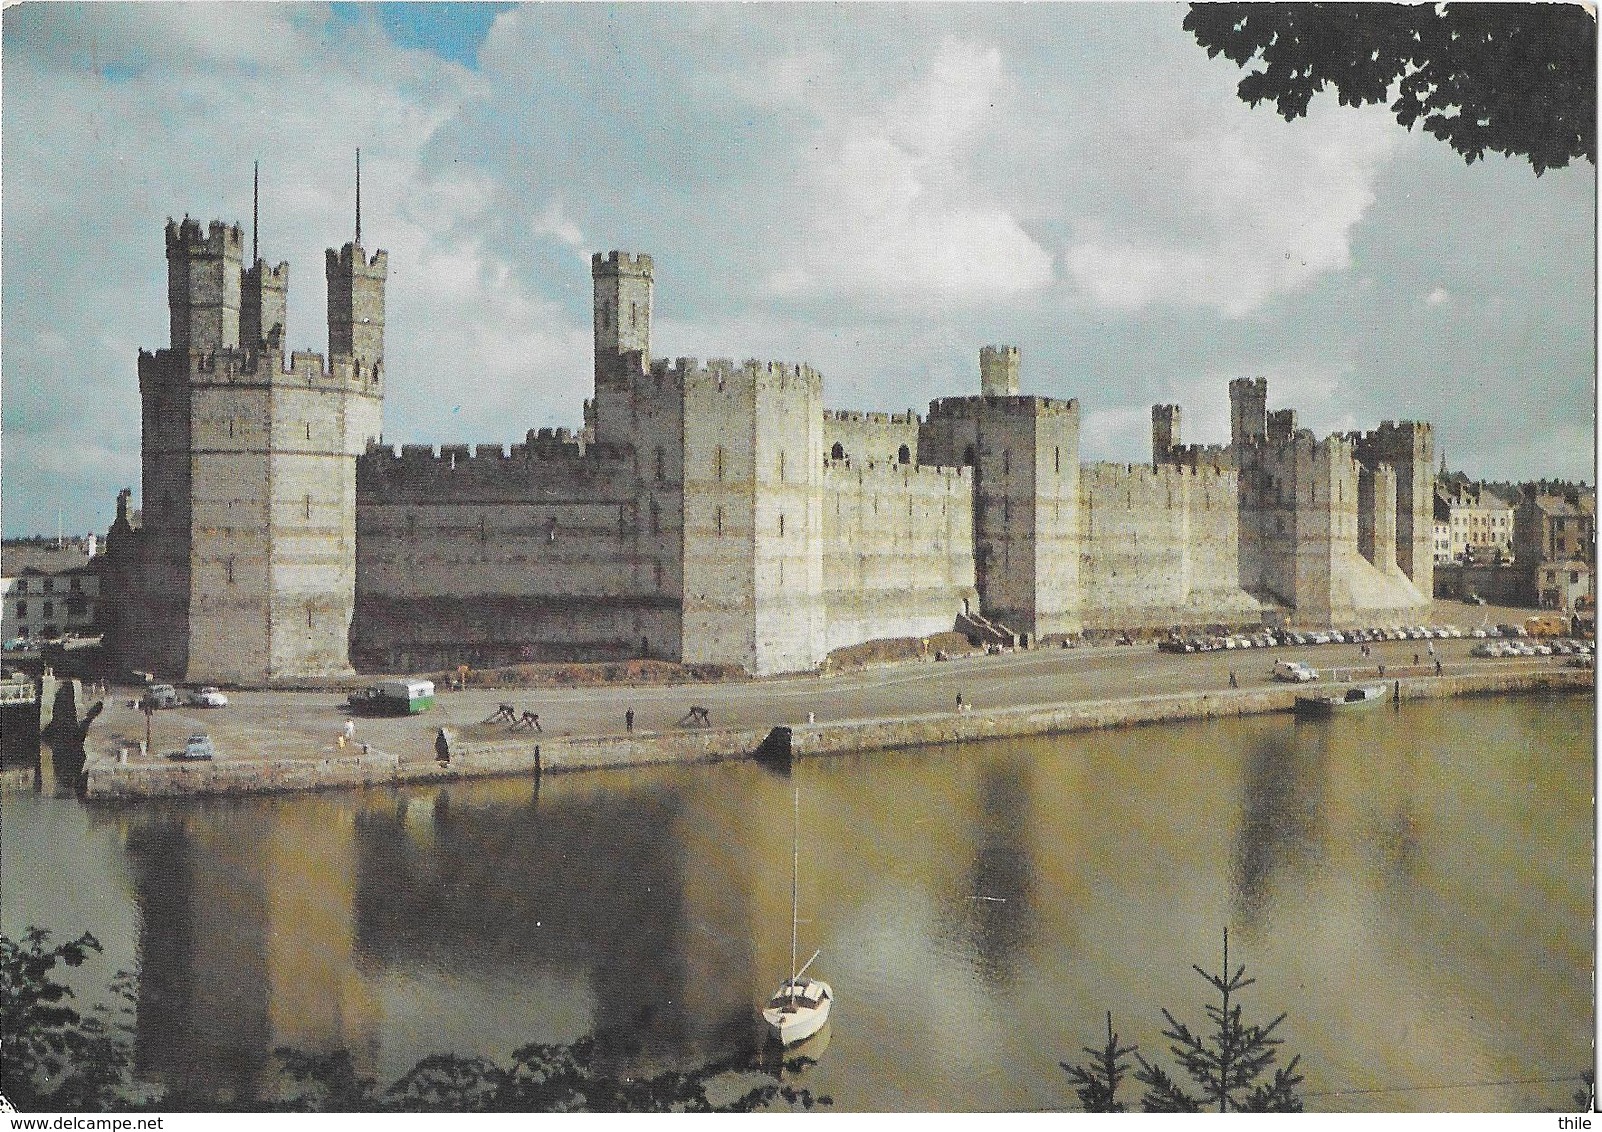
[167,216,245,354]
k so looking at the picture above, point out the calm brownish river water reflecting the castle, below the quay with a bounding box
[0,696,1596,1111]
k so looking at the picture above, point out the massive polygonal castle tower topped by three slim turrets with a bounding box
[117,206,386,685]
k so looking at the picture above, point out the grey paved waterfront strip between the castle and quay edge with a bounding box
[90,605,1562,762]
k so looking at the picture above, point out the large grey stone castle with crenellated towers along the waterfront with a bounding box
[96,206,1434,685]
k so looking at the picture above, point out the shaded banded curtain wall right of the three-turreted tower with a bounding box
[351,429,679,671]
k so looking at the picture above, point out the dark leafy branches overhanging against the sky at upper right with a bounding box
[1184,3,1597,176]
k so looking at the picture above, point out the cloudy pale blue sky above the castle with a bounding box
[0,3,1597,535]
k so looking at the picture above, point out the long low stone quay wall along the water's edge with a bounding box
[82,668,1596,802]
